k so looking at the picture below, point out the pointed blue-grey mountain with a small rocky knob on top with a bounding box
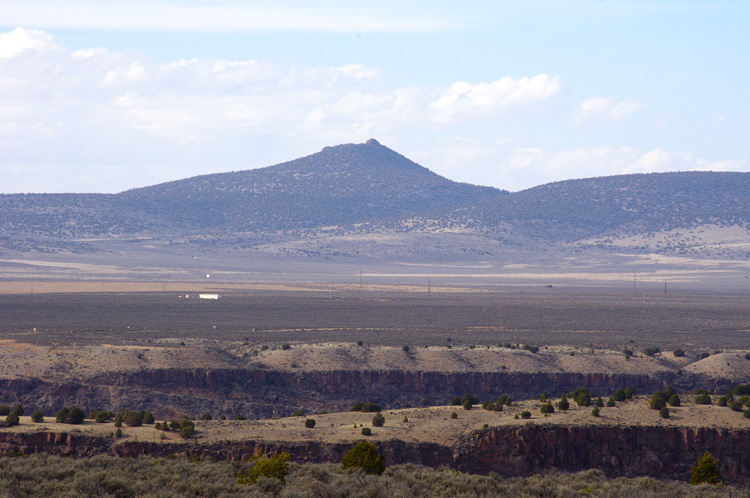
[118,140,507,232]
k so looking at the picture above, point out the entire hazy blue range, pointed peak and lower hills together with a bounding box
[0,140,750,260]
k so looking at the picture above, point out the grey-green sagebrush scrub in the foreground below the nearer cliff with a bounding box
[0,455,750,498]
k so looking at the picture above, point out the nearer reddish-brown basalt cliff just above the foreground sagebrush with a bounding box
[0,424,750,485]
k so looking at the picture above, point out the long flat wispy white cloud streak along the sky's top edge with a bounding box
[0,0,467,32]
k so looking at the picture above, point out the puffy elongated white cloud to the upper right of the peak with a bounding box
[431,74,564,123]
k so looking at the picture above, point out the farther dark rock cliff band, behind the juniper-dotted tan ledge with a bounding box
[0,369,663,417]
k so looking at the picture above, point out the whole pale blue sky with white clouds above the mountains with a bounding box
[0,0,750,193]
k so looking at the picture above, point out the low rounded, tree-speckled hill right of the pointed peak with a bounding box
[480,171,750,235]
